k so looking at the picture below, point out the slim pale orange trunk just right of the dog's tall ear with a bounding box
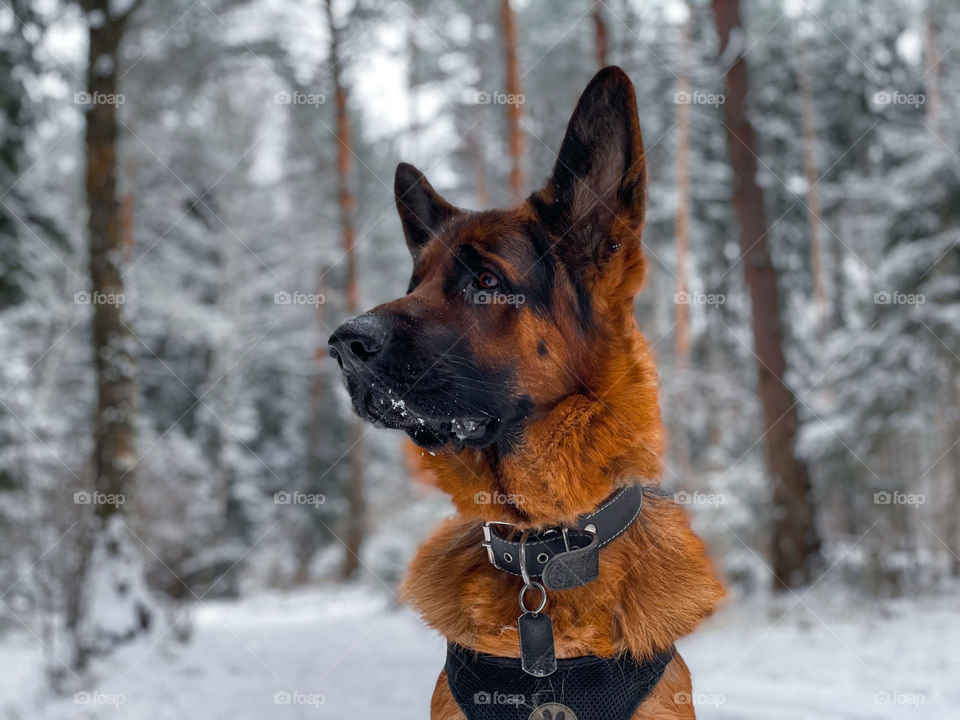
[673,7,692,478]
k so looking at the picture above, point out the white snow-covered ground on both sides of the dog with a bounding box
[0,587,960,720]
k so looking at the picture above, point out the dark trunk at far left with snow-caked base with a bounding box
[67,0,152,668]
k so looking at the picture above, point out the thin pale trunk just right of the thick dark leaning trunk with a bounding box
[797,31,828,339]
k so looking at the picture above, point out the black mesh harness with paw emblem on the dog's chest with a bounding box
[446,644,674,720]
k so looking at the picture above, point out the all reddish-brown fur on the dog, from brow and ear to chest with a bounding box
[386,66,723,720]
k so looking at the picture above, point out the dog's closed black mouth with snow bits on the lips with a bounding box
[354,388,500,450]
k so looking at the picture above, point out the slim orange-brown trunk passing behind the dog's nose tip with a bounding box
[326,0,367,579]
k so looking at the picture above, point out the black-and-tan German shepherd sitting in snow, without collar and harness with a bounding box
[329,67,724,720]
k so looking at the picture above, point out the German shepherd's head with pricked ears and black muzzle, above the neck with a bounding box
[329,67,646,452]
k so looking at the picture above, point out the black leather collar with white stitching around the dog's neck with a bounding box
[483,485,643,590]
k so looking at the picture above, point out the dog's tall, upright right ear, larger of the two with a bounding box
[531,67,646,292]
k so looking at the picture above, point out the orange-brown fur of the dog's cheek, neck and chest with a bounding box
[403,202,723,720]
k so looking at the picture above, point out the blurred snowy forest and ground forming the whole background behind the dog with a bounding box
[0,0,960,720]
